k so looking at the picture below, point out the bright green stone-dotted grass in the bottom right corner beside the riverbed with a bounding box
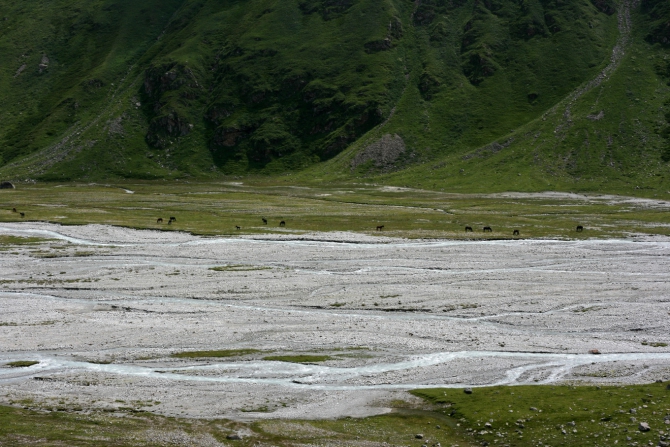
[412,383,670,446]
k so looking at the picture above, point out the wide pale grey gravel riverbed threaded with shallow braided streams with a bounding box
[0,223,670,419]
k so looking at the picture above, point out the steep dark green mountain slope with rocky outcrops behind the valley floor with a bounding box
[0,0,670,194]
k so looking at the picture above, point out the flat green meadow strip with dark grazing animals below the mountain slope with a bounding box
[0,182,670,242]
